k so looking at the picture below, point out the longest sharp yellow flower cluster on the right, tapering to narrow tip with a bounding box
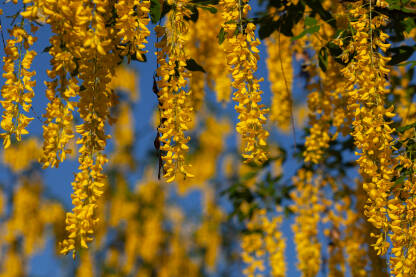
[342,2,394,255]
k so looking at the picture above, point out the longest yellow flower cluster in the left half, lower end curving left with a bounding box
[58,2,117,257]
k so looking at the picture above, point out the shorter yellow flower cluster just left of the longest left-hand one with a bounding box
[37,1,81,168]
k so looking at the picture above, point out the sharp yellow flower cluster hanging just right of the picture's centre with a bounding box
[220,0,269,164]
